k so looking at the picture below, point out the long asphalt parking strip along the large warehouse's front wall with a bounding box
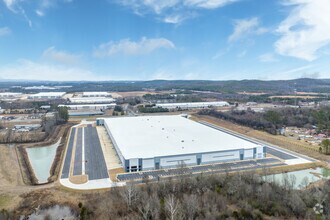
[117,158,286,181]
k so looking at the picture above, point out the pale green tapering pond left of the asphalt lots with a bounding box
[26,139,61,183]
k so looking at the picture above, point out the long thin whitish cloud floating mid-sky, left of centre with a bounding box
[94,37,175,57]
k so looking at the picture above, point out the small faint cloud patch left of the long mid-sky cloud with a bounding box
[42,47,81,65]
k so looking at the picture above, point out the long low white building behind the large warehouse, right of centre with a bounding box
[155,102,229,109]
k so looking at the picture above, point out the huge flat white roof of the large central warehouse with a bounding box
[104,115,258,159]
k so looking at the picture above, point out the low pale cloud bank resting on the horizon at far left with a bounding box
[0,59,99,81]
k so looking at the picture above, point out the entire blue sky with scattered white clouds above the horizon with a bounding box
[0,0,330,80]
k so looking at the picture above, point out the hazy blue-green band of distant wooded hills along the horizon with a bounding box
[0,78,330,94]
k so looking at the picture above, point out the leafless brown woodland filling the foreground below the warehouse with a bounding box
[11,170,330,220]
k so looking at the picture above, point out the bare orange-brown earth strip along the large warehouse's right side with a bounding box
[193,114,330,162]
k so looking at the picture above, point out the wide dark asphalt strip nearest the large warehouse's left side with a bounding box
[84,125,109,180]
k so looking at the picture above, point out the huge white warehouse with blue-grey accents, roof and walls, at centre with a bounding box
[97,115,265,172]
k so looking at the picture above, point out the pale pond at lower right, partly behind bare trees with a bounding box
[265,167,330,189]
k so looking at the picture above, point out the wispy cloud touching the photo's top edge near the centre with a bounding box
[117,0,239,24]
